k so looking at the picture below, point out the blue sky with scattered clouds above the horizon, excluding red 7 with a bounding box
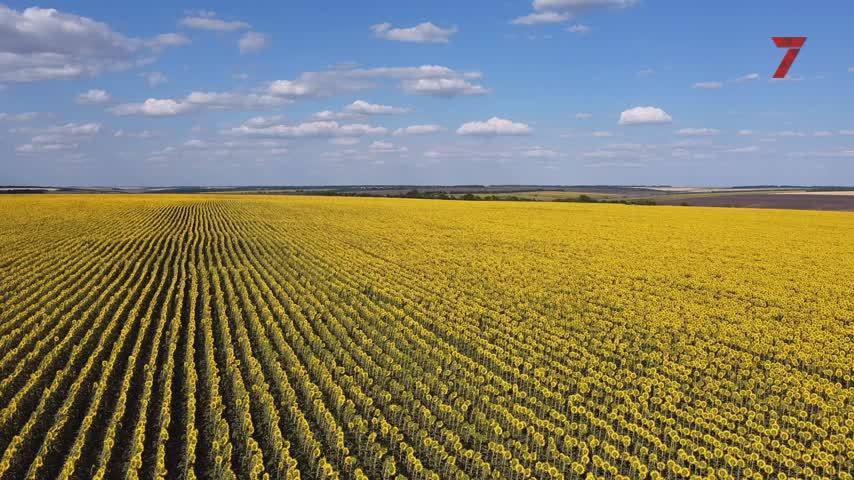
[0,0,854,186]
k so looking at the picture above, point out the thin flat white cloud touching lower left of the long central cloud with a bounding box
[109,92,286,117]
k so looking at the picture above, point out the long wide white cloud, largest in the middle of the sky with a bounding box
[267,65,488,98]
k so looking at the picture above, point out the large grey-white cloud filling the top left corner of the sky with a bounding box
[0,5,187,83]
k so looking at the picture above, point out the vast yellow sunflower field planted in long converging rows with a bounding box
[0,194,854,479]
